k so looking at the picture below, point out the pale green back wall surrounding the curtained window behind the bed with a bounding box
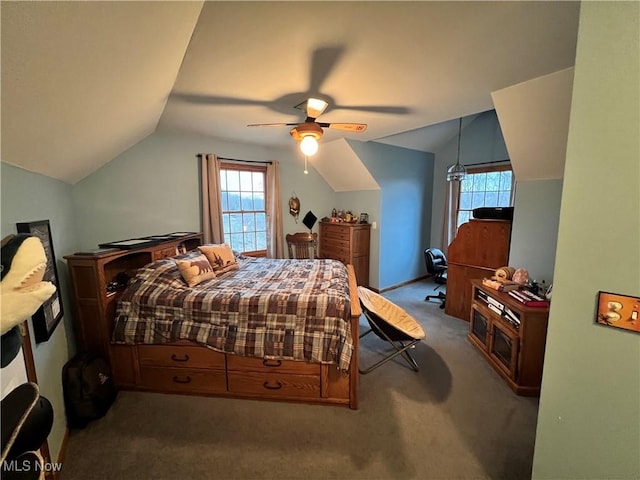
[73,133,334,248]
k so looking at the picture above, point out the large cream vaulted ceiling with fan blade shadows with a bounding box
[1,1,580,183]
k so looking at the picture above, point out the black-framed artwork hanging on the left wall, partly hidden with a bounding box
[16,220,64,343]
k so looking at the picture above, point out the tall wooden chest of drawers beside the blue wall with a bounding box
[320,222,371,287]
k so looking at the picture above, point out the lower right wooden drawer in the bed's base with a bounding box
[229,371,320,398]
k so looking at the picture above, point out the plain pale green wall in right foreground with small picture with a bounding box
[533,2,640,479]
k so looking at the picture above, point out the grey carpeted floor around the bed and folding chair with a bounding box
[62,280,538,480]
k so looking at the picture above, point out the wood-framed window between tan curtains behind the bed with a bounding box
[220,164,267,255]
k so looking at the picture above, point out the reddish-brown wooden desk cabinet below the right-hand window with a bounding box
[444,219,511,320]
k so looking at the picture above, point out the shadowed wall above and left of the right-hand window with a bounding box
[430,110,509,248]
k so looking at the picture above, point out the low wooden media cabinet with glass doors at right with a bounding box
[468,280,549,396]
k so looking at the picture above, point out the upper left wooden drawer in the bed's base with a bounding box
[138,345,225,370]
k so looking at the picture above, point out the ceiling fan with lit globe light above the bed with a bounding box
[247,98,367,156]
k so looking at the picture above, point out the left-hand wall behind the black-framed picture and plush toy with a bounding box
[0,163,77,461]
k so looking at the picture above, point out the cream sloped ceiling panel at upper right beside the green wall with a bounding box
[492,68,573,181]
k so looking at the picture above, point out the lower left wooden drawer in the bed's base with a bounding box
[140,367,227,393]
